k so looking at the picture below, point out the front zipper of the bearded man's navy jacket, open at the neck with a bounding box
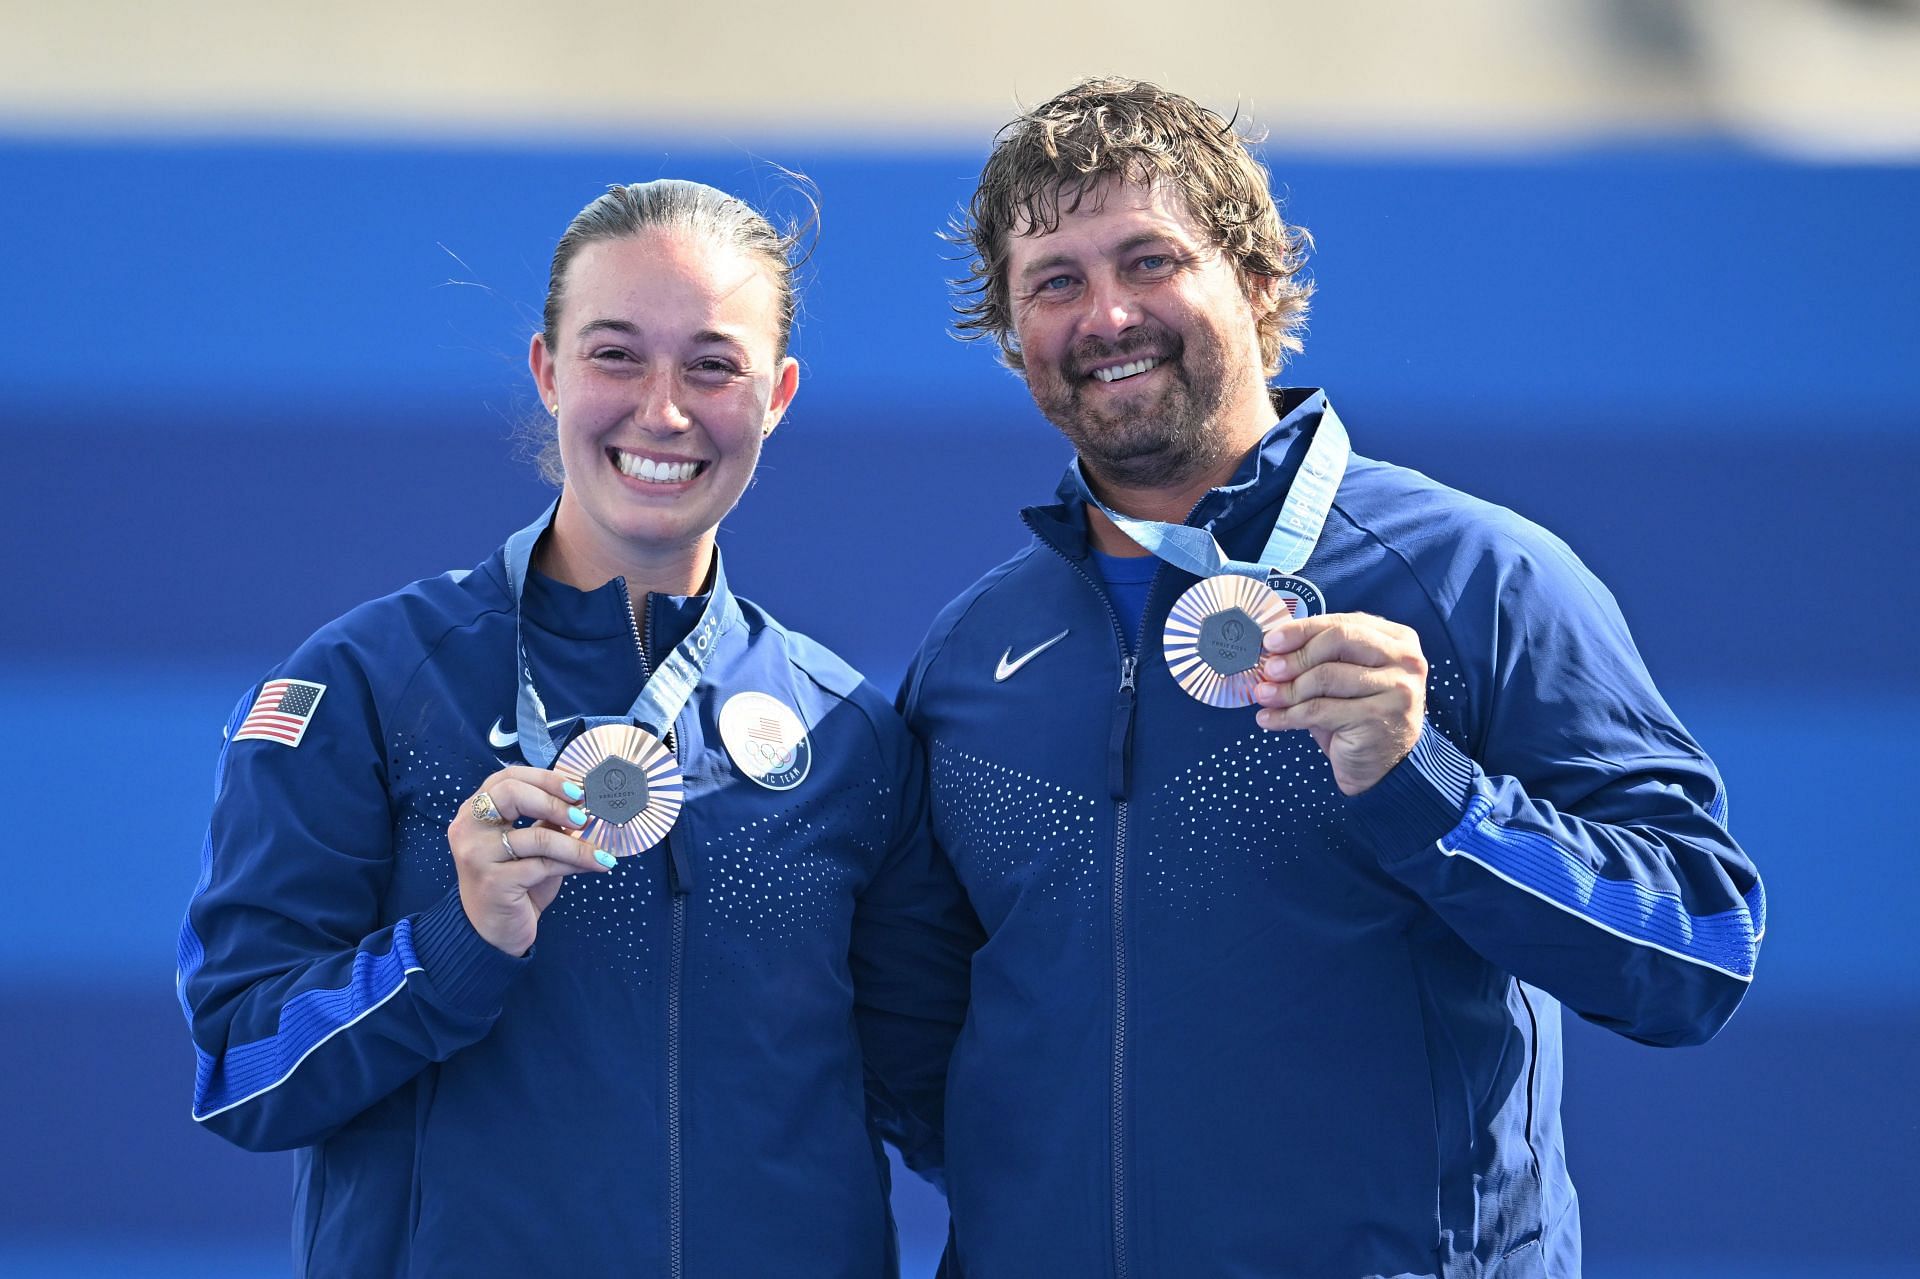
[1023,517,1160,1279]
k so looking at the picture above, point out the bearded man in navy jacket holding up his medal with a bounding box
[902,79,1764,1279]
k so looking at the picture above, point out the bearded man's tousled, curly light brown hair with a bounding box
[948,77,1313,378]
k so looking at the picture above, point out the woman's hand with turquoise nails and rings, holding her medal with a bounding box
[447,764,618,956]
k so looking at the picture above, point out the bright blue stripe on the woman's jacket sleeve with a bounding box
[194,920,422,1122]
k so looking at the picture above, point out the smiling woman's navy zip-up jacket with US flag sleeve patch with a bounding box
[179,522,973,1279]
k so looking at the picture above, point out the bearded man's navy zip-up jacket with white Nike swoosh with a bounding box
[902,392,1764,1279]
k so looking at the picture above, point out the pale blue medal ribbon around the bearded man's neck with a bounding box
[1069,405,1352,582]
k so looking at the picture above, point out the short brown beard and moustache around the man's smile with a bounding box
[1027,334,1229,488]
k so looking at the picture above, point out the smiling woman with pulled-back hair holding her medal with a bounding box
[179,181,973,1279]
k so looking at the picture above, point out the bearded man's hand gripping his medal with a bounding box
[1254,613,1427,795]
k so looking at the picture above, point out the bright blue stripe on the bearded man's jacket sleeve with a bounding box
[1440,795,1764,981]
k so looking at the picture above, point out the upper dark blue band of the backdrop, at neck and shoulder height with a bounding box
[0,409,1920,691]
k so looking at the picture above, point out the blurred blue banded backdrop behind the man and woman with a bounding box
[0,6,1920,1279]
